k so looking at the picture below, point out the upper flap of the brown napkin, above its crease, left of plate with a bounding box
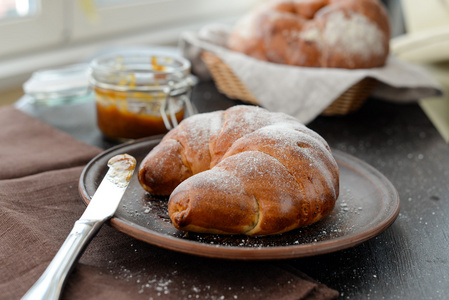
[0,107,100,179]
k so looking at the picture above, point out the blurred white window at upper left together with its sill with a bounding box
[0,0,263,90]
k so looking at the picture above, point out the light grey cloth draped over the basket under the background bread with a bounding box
[180,24,442,124]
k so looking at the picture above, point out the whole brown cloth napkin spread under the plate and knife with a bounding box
[0,107,338,300]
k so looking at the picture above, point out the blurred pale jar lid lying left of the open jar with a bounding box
[23,64,89,101]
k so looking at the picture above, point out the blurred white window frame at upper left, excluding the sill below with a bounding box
[0,0,258,60]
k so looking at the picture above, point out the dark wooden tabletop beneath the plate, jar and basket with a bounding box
[17,83,449,299]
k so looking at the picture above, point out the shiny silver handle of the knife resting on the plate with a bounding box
[22,220,105,300]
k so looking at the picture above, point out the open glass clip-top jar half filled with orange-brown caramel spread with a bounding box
[89,52,196,141]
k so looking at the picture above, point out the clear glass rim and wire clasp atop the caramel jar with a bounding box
[89,51,196,94]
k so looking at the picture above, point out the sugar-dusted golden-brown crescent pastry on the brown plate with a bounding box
[138,105,339,235]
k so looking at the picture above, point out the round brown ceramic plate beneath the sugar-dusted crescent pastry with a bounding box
[79,138,399,260]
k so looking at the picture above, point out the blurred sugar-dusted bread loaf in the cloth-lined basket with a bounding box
[228,0,390,69]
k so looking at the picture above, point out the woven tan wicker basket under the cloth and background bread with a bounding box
[201,51,378,116]
